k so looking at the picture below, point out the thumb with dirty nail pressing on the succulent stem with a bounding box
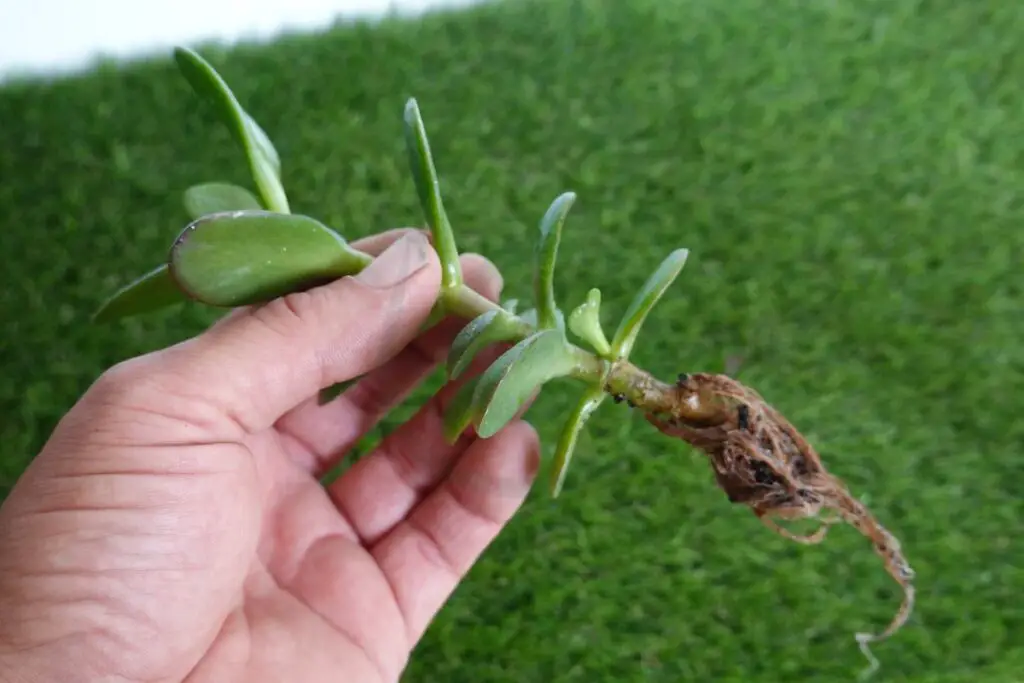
[137,230,440,432]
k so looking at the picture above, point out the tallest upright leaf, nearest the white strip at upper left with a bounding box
[174,47,290,213]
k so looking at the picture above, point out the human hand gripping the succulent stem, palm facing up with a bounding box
[0,230,538,683]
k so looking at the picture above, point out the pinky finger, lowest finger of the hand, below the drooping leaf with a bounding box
[371,421,540,643]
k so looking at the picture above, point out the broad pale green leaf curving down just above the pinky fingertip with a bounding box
[473,330,581,438]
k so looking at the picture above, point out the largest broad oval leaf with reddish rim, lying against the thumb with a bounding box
[170,211,373,306]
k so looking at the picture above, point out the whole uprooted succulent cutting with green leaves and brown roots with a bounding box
[94,48,914,667]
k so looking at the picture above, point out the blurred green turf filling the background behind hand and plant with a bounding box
[0,0,1024,683]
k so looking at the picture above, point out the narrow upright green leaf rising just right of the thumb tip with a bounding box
[406,98,462,288]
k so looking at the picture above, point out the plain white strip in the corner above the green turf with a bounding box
[0,0,475,80]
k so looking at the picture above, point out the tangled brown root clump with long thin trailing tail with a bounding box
[646,374,914,672]
